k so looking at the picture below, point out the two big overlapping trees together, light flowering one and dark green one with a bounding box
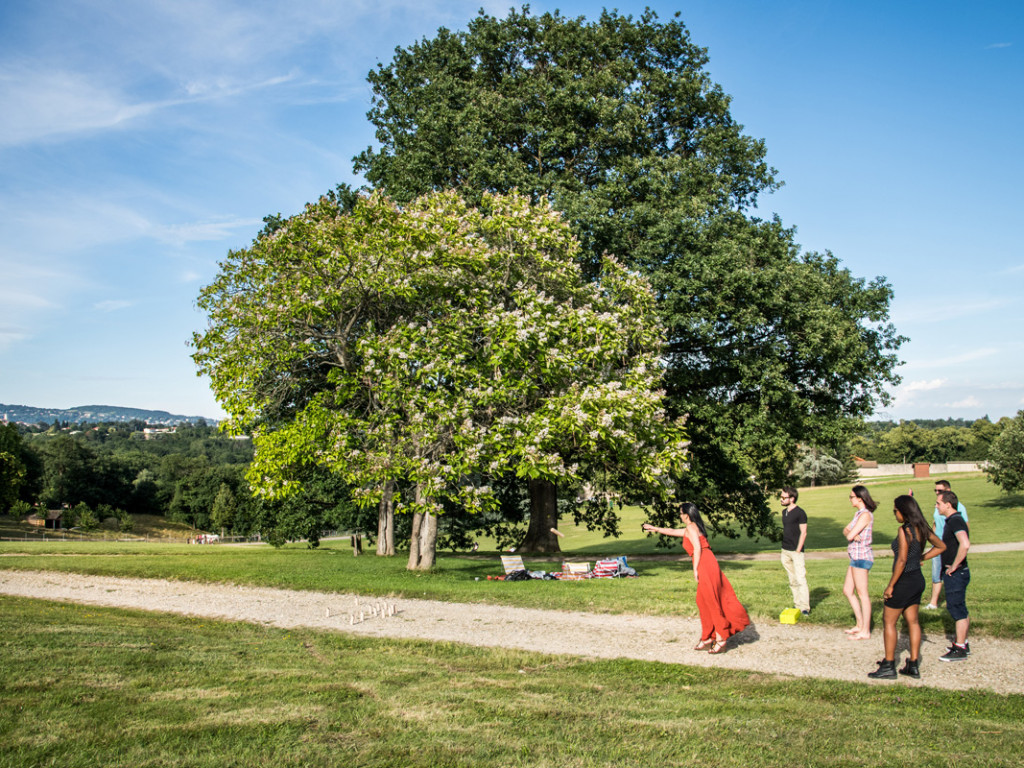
[194,7,902,567]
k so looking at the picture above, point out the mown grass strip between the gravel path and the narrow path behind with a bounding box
[0,542,1024,637]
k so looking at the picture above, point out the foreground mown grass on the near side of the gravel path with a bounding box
[0,598,1024,768]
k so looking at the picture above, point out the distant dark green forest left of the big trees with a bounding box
[0,420,377,541]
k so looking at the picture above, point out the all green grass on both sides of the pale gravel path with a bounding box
[0,477,1024,768]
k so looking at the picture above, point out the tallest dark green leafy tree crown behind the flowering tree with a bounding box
[355,7,901,532]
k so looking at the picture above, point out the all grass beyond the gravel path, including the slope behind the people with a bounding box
[0,475,1024,638]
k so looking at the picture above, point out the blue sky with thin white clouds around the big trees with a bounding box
[0,0,1024,419]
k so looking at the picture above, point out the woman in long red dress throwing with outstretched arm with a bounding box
[643,502,751,653]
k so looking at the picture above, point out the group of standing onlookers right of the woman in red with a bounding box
[780,480,971,679]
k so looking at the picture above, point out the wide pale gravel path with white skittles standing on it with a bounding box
[0,570,1024,693]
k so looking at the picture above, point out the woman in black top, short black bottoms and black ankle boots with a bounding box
[867,496,946,679]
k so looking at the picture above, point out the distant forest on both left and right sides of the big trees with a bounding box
[0,418,1011,544]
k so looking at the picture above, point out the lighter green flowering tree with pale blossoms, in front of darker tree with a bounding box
[194,193,686,568]
